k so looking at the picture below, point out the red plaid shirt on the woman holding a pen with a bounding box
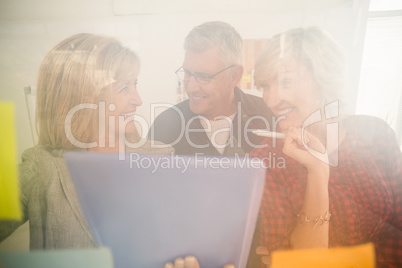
[250,116,402,267]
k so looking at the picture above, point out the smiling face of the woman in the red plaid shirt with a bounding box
[260,60,323,131]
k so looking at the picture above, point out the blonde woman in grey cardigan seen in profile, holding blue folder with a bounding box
[0,34,172,249]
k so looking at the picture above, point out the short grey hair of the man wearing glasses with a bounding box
[184,21,243,65]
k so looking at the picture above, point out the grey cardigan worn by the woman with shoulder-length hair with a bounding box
[0,142,173,249]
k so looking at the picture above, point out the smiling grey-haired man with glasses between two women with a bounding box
[149,21,273,156]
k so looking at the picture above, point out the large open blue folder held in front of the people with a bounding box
[65,152,266,268]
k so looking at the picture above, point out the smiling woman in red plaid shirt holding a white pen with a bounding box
[250,27,402,267]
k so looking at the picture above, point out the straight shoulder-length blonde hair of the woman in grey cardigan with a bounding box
[36,33,139,149]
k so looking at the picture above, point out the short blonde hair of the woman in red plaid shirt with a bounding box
[254,27,346,103]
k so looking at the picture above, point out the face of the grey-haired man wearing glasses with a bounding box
[183,46,238,119]
